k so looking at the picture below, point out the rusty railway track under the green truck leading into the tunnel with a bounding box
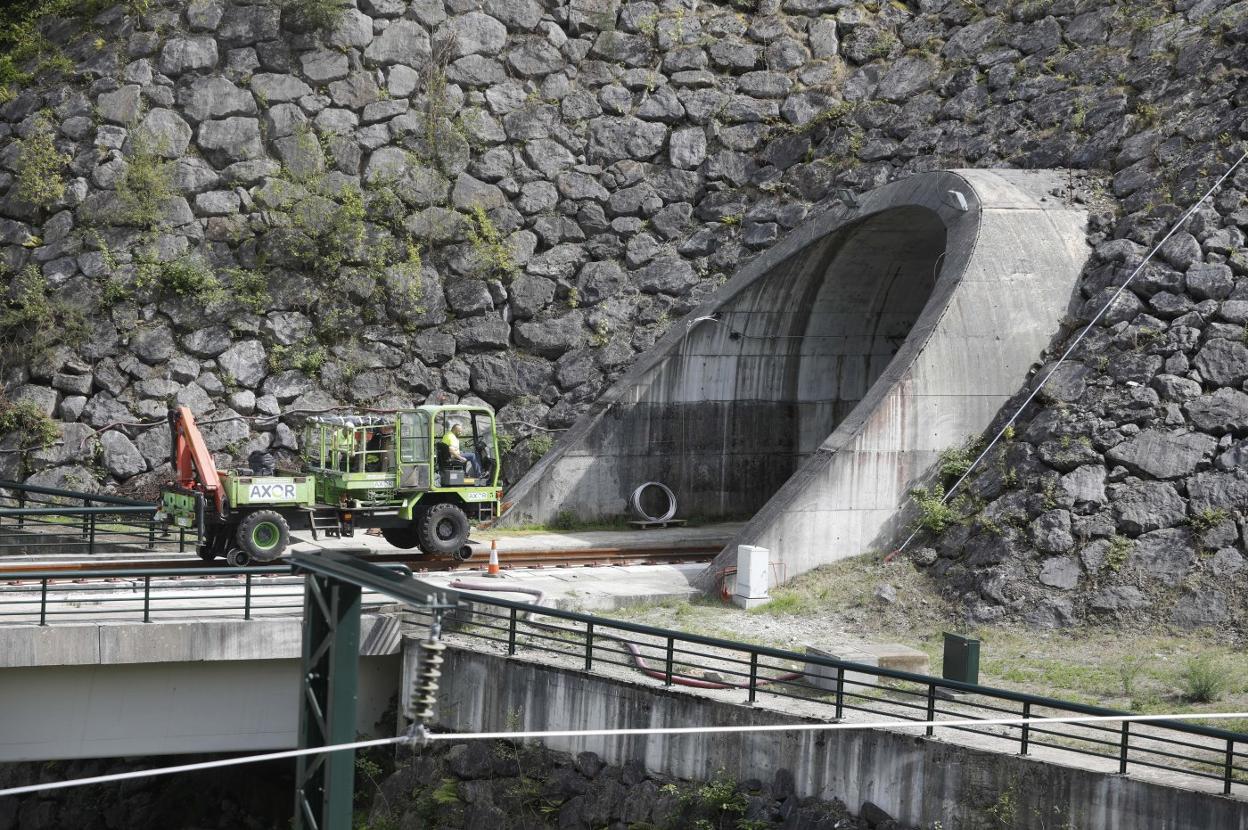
[0,545,720,580]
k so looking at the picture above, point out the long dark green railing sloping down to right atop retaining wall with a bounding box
[409,594,1248,794]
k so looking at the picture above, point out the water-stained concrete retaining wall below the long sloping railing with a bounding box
[419,642,1248,830]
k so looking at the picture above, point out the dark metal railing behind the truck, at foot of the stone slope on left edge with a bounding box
[0,481,200,557]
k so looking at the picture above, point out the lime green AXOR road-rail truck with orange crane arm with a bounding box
[157,406,502,565]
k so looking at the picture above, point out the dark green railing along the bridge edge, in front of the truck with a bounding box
[0,563,412,625]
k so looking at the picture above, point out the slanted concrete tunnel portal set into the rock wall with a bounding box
[504,170,1088,575]
